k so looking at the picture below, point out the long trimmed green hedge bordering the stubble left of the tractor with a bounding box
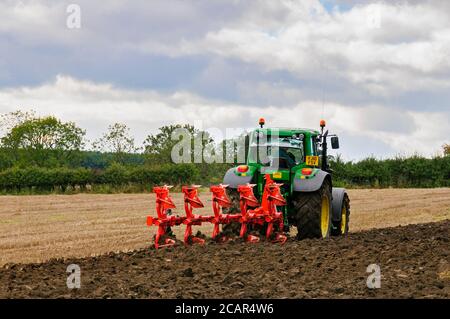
[0,163,199,194]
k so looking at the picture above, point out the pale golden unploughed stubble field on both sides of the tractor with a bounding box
[0,189,450,265]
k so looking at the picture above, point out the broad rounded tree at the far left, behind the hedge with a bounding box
[1,116,86,166]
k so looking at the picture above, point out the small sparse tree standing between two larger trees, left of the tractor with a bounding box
[92,123,139,164]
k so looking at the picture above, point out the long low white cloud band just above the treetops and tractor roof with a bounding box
[0,75,450,158]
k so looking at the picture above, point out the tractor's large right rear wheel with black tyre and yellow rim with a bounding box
[293,180,331,239]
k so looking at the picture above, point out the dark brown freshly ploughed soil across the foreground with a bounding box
[0,220,450,298]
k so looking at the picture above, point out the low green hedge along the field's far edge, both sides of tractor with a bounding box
[0,156,450,194]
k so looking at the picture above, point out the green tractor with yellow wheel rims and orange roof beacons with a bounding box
[223,119,350,239]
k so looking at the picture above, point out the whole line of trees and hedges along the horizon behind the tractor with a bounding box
[0,111,450,194]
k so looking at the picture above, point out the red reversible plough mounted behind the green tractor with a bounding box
[147,175,287,249]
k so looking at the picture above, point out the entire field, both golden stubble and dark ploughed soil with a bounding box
[0,189,450,298]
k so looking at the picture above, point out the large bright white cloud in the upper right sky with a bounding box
[180,1,450,96]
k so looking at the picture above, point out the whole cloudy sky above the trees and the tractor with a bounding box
[0,0,450,160]
